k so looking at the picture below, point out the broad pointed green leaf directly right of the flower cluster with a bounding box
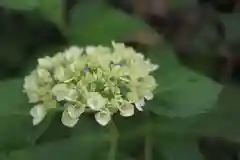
[148,43,222,117]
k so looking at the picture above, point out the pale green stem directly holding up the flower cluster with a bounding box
[108,121,119,160]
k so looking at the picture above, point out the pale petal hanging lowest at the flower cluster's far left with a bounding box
[30,104,47,126]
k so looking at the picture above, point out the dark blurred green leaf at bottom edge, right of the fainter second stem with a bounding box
[154,135,204,160]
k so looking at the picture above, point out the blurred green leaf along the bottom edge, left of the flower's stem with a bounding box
[7,137,107,160]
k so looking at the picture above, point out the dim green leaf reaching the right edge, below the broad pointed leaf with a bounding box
[150,84,240,142]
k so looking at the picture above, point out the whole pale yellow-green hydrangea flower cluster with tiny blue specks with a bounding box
[24,42,158,127]
